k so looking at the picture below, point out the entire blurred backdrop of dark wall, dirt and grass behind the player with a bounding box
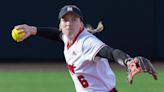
[0,0,164,92]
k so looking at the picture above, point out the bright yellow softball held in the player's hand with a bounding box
[11,28,26,42]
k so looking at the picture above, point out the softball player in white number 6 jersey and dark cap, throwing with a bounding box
[16,5,157,92]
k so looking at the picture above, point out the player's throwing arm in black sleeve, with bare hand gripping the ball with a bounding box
[15,24,62,42]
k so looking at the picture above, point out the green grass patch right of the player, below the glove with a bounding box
[116,70,164,92]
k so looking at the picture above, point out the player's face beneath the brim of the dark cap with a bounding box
[59,12,83,39]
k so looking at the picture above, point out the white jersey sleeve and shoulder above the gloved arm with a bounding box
[83,36,106,61]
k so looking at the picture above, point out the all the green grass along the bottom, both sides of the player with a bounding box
[0,69,164,92]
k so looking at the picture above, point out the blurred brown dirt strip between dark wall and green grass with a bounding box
[0,62,164,71]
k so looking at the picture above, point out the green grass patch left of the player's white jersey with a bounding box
[0,71,74,92]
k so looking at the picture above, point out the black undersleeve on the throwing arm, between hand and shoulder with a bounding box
[36,27,63,42]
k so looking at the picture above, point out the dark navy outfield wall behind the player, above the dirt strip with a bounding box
[0,0,164,62]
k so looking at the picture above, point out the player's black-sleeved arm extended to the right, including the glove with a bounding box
[97,46,157,84]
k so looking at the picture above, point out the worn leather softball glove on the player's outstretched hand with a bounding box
[125,56,157,84]
